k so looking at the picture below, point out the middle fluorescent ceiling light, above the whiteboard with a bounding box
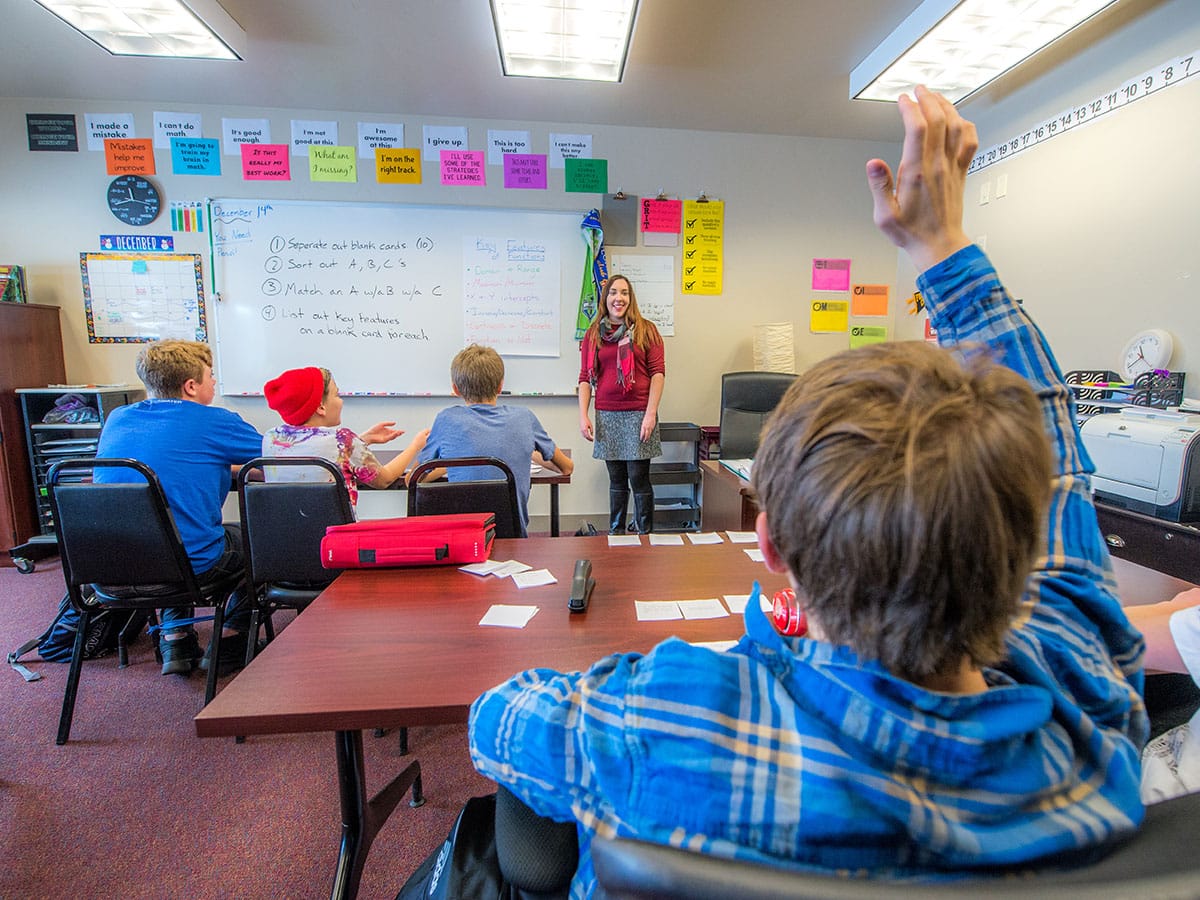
[491,0,637,82]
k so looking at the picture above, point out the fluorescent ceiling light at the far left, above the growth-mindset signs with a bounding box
[35,0,246,59]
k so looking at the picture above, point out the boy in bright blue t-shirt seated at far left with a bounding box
[96,341,263,676]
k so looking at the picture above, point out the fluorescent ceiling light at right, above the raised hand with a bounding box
[850,0,1116,103]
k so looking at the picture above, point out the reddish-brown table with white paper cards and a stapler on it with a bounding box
[196,535,1193,898]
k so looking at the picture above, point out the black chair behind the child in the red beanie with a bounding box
[238,456,354,662]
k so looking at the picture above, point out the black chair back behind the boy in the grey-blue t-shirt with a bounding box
[408,456,526,538]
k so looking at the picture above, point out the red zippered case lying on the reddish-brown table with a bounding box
[320,512,496,569]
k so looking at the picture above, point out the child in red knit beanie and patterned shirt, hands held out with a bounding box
[263,366,430,504]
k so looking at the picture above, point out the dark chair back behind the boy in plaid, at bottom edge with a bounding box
[592,793,1200,900]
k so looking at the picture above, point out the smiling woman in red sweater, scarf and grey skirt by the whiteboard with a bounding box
[580,275,666,534]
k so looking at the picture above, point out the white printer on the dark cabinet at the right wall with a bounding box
[1080,407,1200,522]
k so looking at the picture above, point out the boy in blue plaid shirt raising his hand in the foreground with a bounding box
[469,88,1147,898]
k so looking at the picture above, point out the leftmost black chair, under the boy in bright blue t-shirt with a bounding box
[47,458,239,744]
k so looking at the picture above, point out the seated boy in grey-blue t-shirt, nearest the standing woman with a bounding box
[419,344,575,532]
